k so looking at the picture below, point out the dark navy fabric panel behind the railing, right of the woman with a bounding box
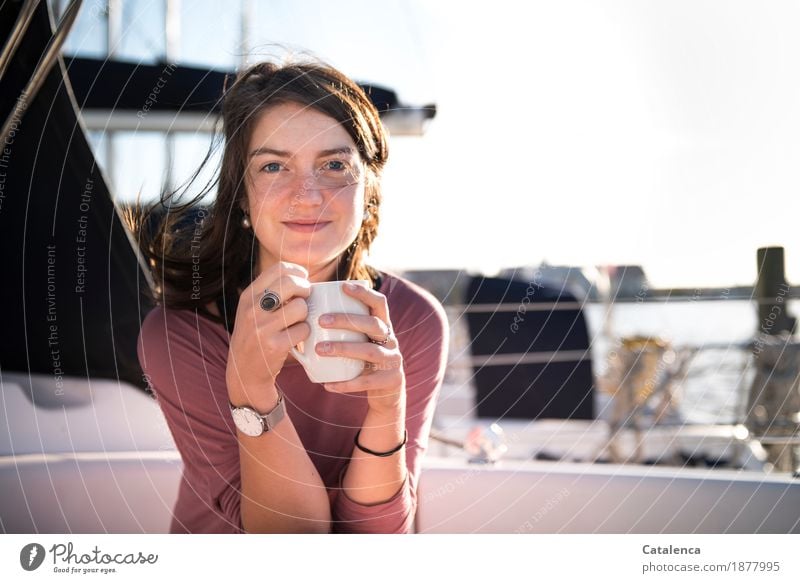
[466,277,594,419]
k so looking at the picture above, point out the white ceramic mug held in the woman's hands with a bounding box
[292,279,370,383]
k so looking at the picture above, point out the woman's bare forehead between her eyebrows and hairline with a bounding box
[249,103,355,153]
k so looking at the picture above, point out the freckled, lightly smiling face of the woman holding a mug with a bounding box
[246,103,365,281]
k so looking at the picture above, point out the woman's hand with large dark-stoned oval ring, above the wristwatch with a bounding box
[225,262,311,406]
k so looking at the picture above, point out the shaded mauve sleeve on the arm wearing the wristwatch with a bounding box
[138,307,243,532]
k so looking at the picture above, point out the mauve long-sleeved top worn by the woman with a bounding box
[138,272,448,533]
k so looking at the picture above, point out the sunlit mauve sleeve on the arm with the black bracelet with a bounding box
[331,288,449,534]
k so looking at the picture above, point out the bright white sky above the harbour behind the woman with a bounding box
[69,0,800,286]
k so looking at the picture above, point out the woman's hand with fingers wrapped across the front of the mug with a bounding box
[316,284,406,413]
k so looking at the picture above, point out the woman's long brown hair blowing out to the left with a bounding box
[128,62,389,330]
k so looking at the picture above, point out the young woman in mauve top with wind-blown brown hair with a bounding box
[138,63,448,533]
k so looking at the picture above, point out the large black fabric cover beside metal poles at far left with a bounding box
[0,2,151,388]
